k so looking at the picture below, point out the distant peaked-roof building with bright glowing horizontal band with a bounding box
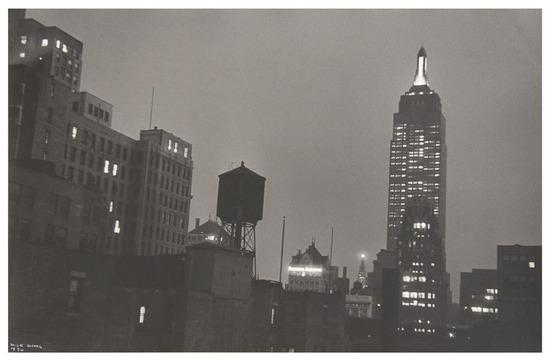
[288,241,338,293]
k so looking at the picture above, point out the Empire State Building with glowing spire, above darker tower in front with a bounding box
[387,47,447,250]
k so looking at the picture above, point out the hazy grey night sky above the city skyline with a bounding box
[27,10,542,300]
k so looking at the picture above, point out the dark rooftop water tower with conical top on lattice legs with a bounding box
[216,162,265,270]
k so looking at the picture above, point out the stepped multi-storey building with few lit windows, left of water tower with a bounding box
[9,11,193,255]
